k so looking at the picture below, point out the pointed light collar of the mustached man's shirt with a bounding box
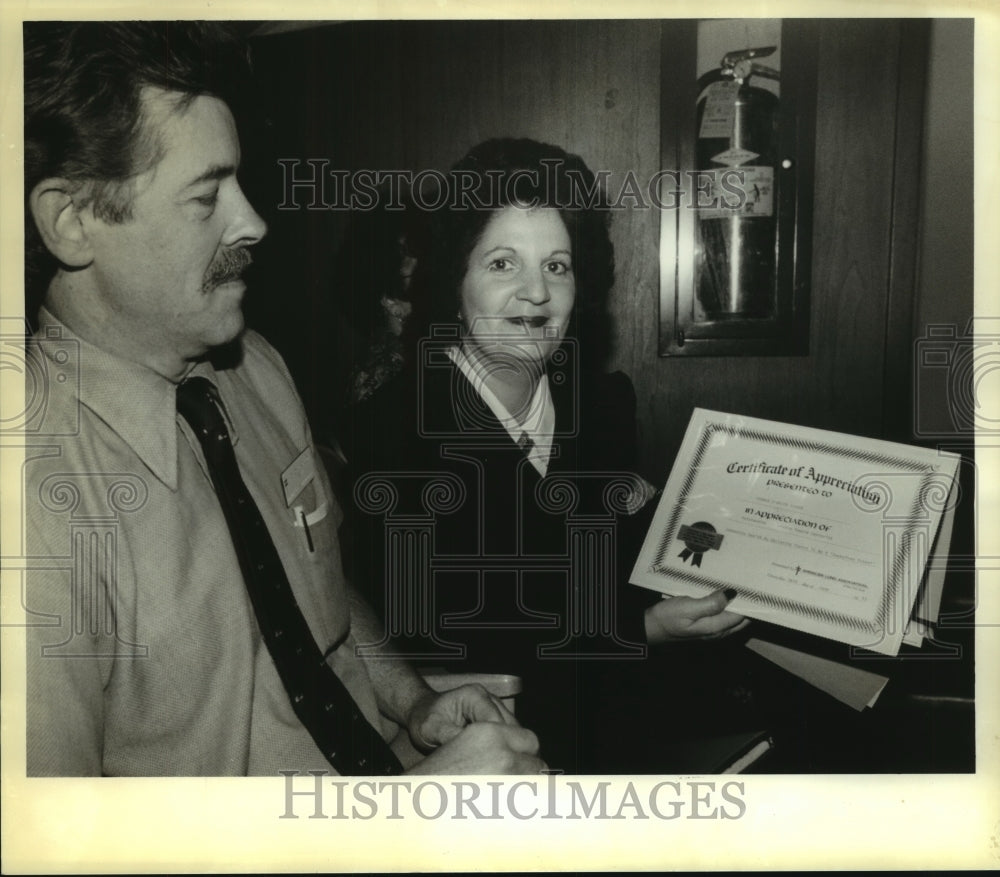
[35,307,222,490]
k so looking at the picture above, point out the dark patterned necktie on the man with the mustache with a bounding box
[177,377,402,776]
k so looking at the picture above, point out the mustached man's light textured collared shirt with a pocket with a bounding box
[24,311,380,776]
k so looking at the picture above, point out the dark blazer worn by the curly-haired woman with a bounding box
[340,350,657,772]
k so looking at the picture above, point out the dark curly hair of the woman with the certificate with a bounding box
[407,138,615,365]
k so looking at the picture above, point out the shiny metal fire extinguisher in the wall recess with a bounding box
[695,46,779,320]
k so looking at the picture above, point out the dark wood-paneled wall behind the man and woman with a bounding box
[245,20,936,481]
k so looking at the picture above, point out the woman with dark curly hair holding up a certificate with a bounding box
[340,139,742,772]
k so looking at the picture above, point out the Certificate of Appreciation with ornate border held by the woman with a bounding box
[631,409,959,655]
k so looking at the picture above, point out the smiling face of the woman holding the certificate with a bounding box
[459,206,576,360]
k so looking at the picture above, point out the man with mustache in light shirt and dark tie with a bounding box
[25,22,543,776]
